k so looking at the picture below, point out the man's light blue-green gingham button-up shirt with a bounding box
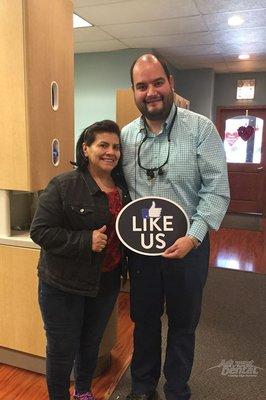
[121,105,230,241]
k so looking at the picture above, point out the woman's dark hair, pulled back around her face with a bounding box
[71,119,121,175]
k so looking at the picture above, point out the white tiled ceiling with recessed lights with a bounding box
[73,0,266,73]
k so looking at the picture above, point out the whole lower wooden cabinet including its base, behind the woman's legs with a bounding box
[0,245,117,373]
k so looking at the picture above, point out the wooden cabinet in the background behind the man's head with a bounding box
[116,88,190,128]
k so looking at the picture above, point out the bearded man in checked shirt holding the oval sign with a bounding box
[122,54,229,400]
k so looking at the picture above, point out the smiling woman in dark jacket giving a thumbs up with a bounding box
[30,120,128,400]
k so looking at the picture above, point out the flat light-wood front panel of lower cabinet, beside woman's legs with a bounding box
[0,245,45,357]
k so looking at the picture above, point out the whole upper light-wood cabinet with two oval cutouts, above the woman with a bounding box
[0,0,74,191]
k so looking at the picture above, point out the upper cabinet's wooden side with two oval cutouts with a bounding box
[25,0,74,190]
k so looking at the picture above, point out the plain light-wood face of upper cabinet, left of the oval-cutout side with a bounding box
[0,0,28,189]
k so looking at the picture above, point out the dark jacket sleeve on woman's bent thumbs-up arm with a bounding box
[30,178,92,261]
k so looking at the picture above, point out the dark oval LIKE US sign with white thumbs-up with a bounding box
[116,197,189,256]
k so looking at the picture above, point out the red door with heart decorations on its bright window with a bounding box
[217,106,266,214]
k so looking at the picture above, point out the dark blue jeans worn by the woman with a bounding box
[39,268,120,400]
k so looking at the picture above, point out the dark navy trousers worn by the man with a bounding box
[129,236,209,400]
